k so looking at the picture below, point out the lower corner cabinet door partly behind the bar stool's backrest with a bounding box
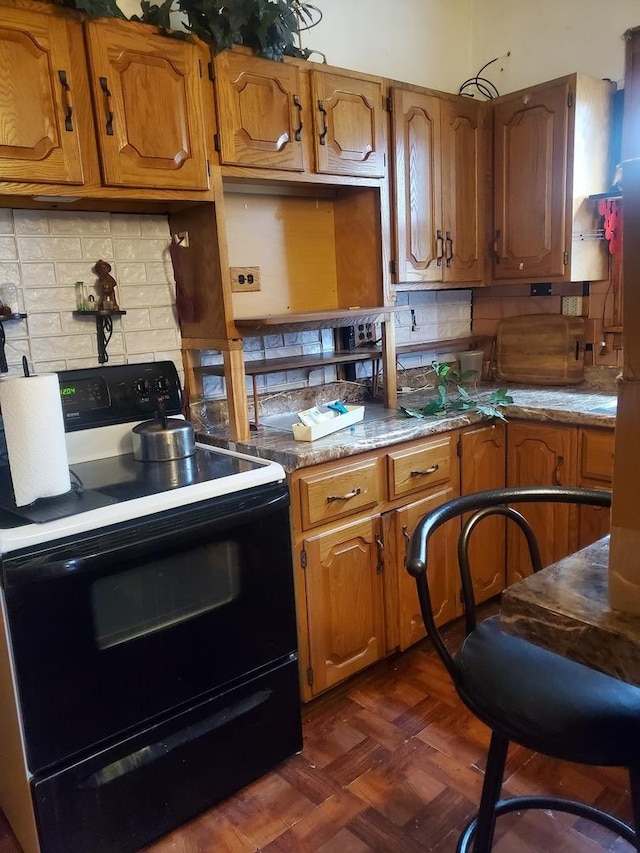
[507,421,578,585]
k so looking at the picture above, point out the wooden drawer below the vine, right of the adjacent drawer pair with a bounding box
[387,435,454,500]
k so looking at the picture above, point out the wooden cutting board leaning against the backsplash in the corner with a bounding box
[496,314,584,385]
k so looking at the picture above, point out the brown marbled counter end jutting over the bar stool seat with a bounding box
[500,536,640,685]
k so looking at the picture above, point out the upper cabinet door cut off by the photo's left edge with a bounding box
[0,7,83,184]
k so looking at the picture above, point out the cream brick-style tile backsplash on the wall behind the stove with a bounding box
[0,210,183,376]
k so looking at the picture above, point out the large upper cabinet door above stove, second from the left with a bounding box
[86,20,209,190]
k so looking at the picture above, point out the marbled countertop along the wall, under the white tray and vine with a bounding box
[198,384,616,471]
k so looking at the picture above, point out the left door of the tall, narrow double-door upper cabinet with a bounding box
[391,88,444,282]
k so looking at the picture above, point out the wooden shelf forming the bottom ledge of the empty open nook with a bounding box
[234,305,410,334]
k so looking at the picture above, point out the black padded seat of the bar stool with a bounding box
[454,616,640,767]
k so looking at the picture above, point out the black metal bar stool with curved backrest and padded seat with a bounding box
[407,486,640,853]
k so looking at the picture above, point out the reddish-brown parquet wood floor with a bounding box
[0,608,632,853]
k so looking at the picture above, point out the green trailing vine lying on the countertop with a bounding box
[400,361,513,421]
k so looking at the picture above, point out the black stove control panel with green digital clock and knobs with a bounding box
[58,361,182,432]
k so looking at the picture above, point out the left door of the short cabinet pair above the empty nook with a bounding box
[215,50,305,172]
